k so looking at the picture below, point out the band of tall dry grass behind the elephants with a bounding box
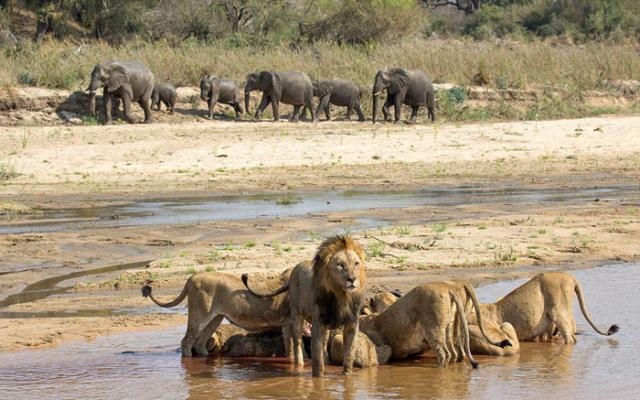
[0,39,640,90]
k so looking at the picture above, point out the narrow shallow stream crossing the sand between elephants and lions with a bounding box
[0,186,640,234]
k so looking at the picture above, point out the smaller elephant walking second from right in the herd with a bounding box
[302,79,366,122]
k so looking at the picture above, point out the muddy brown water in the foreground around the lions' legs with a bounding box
[0,264,640,399]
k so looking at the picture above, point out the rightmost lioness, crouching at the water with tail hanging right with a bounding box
[480,272,618,343]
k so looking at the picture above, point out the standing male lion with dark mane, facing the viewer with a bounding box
[242,236,366,376]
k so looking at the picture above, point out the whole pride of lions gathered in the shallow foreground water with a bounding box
[142,236,618,376]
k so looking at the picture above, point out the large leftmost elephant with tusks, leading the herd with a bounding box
[88,61,154,124]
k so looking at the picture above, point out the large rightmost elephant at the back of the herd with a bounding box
[373,68,436,124]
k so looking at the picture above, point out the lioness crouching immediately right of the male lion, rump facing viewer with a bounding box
[361,282,478,368]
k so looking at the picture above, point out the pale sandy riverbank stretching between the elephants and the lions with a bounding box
[0,117,640,350]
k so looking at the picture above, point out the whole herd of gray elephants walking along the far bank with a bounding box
[87,61,435,124]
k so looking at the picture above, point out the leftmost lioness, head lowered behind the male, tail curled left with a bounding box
[142,269,291,357]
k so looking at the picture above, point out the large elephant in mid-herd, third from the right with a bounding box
[244,71,317,122]
